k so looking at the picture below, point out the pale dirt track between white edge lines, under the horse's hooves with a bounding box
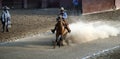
[0,33,120,59]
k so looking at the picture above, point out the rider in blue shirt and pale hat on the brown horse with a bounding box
[51,7,71,33]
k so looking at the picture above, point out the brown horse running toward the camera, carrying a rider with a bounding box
[54,17,68,48]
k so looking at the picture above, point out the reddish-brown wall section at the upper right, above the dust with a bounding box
[82,0,115,13]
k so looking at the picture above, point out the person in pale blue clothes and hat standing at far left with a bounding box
[1,6,11,32]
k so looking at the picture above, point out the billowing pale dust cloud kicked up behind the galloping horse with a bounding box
[67,21,119,43]
